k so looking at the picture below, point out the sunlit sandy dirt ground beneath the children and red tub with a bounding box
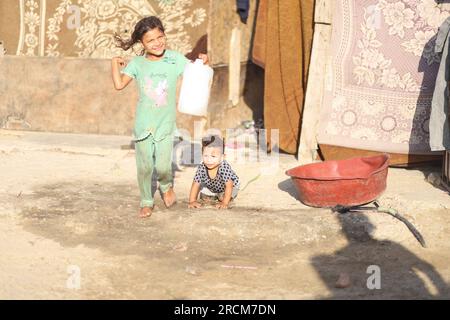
[0,130,450,299]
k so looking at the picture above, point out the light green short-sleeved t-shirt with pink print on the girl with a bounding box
[122,50,189,141]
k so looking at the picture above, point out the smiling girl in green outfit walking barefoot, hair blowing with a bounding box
[112,16,208,218]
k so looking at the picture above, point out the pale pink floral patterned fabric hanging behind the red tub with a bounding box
[318,0,450,154]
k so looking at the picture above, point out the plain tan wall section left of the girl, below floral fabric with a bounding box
[0,56,137,134]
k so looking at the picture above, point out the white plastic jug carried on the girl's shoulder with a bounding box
[178,59,214,116]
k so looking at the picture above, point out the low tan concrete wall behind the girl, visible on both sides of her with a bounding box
[0,55,263,135]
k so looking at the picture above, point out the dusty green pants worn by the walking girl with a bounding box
[135,135,173,208]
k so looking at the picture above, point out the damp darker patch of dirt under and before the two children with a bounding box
[18,181,320,264]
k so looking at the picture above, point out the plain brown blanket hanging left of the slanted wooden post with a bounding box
[264,0,314,154]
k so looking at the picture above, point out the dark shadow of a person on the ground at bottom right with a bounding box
[311,213,449,299]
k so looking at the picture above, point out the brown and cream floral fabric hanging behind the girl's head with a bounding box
[0,0,209,58]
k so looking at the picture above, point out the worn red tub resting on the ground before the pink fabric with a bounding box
[286,154,389,208]
